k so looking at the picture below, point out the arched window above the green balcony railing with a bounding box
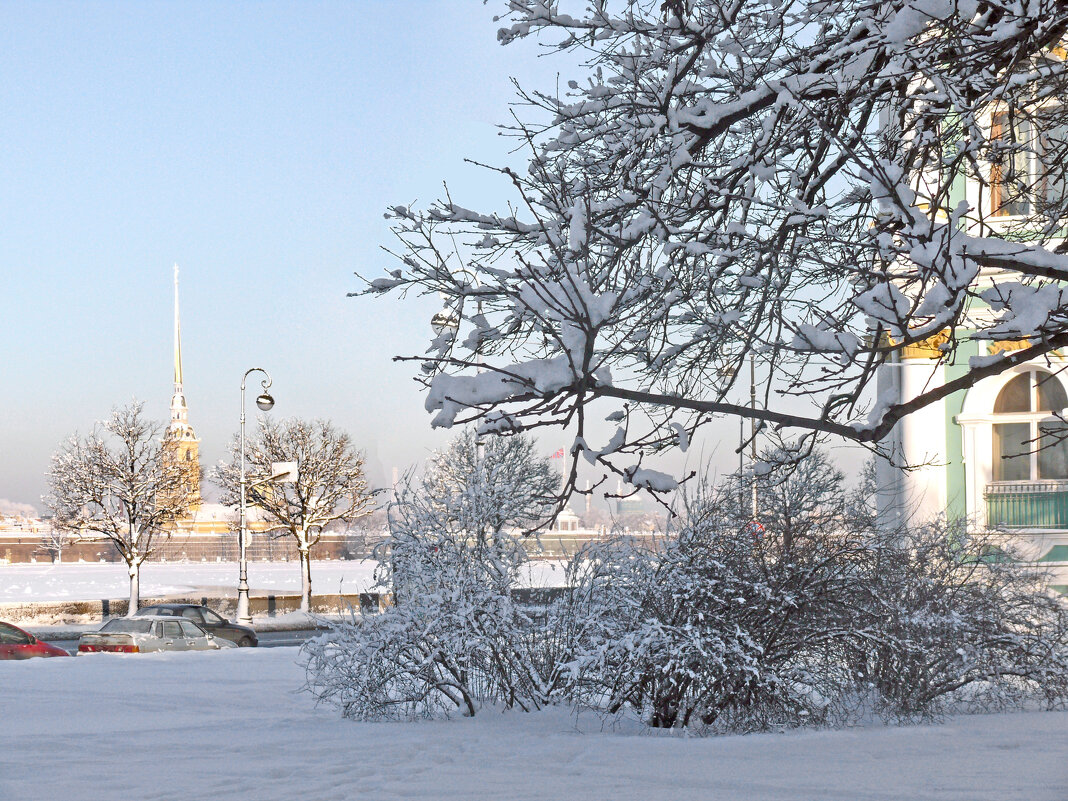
[993,370,1068,482]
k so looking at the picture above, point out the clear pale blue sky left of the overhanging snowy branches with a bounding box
[0,0,576,506]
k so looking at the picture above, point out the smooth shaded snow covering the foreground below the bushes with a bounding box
[0,648,1068,801]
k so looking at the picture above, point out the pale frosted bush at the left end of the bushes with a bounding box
[308,529,524,719]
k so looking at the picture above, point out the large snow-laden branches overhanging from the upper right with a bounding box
[362,0,1068,499]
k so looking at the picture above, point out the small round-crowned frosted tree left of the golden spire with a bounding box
[44,403,193,614]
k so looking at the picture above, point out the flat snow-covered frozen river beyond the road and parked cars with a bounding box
[0,560,562,603]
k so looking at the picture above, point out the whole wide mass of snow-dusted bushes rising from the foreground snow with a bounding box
[307,449,1068,733]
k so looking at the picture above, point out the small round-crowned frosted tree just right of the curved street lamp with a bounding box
[214,418,372,612]
